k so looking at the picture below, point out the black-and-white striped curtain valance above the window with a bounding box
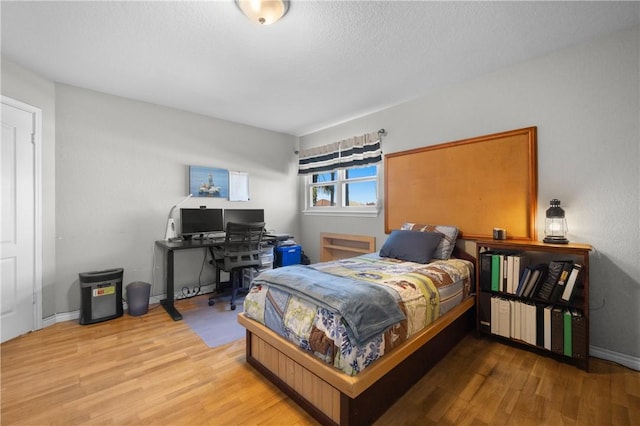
[298,132,382,175]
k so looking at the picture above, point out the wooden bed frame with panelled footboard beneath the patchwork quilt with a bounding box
[238,246,475,425]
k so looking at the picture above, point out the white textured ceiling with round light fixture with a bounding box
[1,0,640,136]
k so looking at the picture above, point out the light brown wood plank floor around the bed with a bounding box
[0,294,640,426]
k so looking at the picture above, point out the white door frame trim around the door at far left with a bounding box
[1,95,43,331]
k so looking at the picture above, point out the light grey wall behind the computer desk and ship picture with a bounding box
[55,84,298,312]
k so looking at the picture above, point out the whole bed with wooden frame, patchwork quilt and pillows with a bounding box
[238,223,475,425]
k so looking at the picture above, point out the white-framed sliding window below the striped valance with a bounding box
[305,165,378,216]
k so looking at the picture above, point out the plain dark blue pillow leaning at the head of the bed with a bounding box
[380,230,443,263]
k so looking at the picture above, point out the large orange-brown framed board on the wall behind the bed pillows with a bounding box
[384,127,538,240]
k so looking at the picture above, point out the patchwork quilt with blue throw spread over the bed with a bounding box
[244,253,473,375]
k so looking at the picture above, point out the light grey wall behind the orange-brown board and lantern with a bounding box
[299,27,640,366]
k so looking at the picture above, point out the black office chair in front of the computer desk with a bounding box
[209,222,264,311]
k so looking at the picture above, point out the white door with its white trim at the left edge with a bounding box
[0,97,41,342]
